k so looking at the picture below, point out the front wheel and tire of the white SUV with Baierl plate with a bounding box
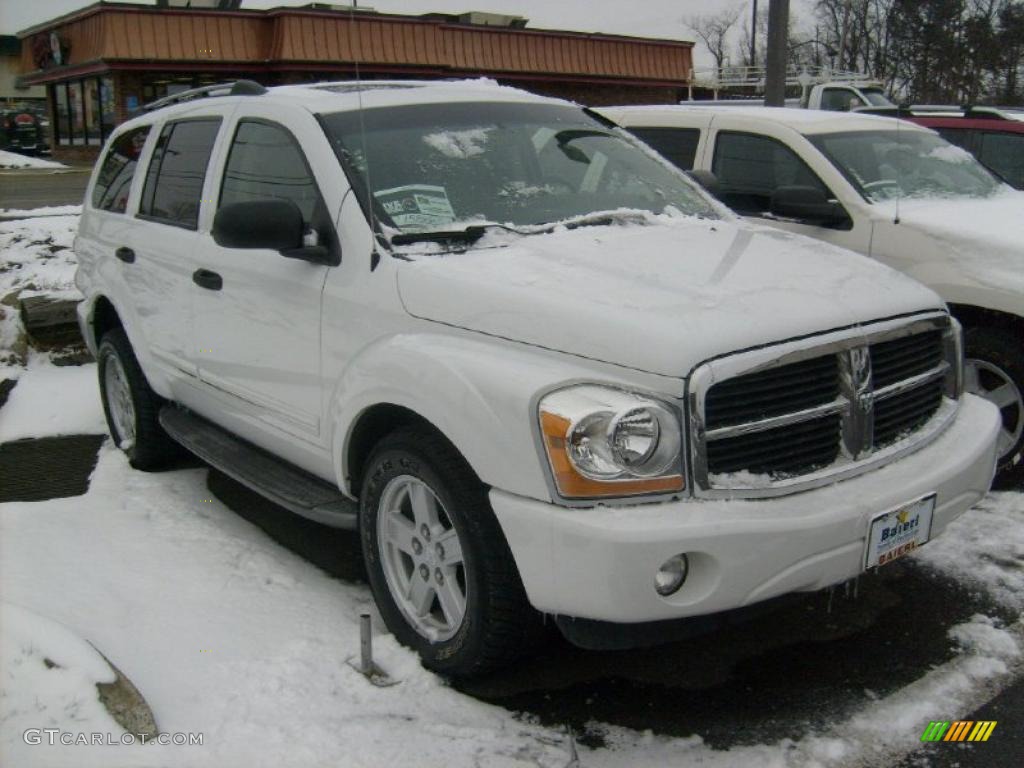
[359,428,538,677]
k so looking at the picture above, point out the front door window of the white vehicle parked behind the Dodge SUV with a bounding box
[712,133,833,213]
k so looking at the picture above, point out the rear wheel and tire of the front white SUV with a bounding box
[96,328,180,470]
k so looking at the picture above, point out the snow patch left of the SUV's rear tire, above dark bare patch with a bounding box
[0,355,106,442]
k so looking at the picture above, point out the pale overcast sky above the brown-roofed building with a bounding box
[0,0,808,67]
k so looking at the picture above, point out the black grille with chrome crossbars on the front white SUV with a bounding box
[695,319,949,487]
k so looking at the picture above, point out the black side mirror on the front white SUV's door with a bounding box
[212,200,305,251]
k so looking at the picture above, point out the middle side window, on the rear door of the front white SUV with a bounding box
[138,118,220,229]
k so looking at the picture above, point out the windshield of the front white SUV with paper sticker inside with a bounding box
[323,102,716,232]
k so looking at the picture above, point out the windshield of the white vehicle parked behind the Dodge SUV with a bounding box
[808,129,1001,203]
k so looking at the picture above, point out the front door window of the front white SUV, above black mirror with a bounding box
[220,121,319,223]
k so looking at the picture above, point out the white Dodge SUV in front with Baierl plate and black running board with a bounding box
[76,81,998,675]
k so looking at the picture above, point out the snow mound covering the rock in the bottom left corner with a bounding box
[0,602,120,733]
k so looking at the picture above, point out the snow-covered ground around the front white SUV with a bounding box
[0,207,1024,768]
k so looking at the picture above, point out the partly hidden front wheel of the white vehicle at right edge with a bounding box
[964,326,1024,488]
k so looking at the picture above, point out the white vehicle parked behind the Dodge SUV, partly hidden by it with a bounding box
[601,106,1024,486]
